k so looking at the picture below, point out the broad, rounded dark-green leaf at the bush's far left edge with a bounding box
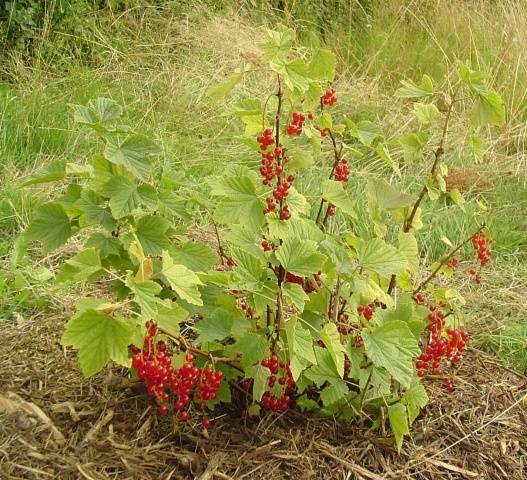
[25,203,72,252]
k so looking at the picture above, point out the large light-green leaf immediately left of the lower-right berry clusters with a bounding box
[362,320,420,388]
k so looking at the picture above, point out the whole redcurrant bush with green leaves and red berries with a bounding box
[25,27,504,454]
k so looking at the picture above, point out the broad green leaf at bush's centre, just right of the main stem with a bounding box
[276,237,326,276]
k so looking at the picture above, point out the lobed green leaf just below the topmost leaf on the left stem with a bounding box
[104,134,160,180]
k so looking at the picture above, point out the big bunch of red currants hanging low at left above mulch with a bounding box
[132,321,223,428]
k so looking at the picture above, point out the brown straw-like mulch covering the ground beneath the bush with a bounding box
[0,317,527,480]
